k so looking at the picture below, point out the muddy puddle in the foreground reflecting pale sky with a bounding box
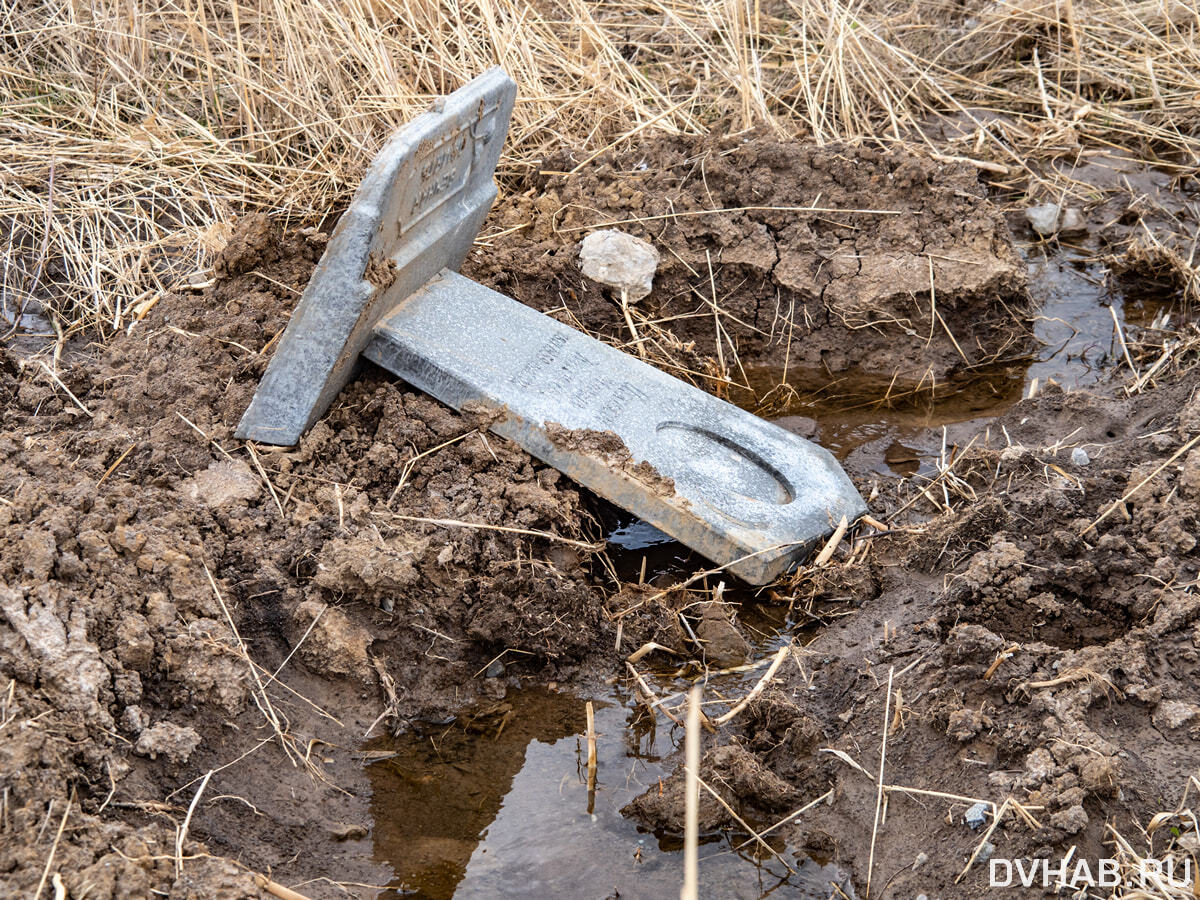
[367,676,852,900]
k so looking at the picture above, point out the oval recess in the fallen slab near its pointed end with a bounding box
[658,421,794,515]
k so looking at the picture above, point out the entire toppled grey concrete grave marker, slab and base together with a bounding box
[238,68,866,584]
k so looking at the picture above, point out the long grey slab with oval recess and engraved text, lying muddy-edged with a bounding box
[365,271,866,584]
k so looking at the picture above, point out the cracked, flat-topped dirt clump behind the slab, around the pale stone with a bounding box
[464,136,1027,386]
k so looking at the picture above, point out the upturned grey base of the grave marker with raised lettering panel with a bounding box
[236,68,517,446]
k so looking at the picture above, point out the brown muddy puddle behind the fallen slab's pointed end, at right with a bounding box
[715,245,1181,478]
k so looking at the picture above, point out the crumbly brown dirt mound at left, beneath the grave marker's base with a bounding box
[0,217,611,896]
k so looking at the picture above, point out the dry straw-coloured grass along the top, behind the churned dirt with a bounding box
[0,0,1200,336]
